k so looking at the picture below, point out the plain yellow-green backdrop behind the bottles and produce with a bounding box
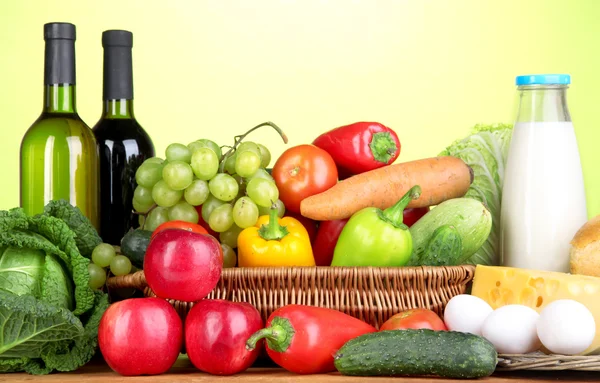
[0,0,600,219]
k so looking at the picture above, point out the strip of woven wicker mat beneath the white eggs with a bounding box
[496,353,600,371]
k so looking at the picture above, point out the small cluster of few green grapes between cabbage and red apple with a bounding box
[88,243,132,289]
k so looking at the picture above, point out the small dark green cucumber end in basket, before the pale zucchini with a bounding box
[420,225,462,266]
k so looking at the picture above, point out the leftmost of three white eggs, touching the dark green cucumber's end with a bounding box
[444,294,494,335]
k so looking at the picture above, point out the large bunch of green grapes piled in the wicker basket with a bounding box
[133,139,285,248]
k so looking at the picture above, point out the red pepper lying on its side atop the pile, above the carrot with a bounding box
[313,122,400,180]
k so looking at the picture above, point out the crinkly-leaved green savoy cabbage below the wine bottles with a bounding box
[0,202,108,374]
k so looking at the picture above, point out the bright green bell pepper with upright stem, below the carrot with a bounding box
[331,185,421,267]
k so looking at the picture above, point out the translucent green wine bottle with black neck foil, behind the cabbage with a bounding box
[20,23,99,228]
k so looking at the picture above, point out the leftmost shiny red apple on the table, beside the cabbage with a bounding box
[98,298,183,376]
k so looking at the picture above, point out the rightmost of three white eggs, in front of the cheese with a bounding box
[537,299,596,355]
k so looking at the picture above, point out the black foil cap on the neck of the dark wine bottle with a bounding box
[102,30,133,101]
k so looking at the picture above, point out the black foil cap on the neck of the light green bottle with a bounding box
[44,23,76,85]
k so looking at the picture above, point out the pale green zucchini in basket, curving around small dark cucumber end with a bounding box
[408,198,492,266]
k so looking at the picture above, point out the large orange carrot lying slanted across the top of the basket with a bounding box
[300,156,473,221]
